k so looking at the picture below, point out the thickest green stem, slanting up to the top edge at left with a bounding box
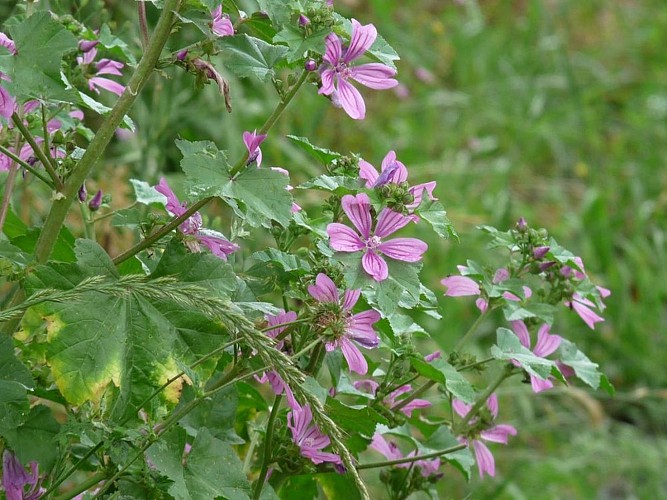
[32,0,180,263]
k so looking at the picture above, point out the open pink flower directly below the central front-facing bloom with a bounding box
[308,273,380,375]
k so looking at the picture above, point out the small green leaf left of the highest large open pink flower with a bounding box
[217,35,289,82]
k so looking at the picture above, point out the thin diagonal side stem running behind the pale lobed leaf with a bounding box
[113,71,307,265]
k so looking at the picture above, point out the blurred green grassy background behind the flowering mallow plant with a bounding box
[49,0,667,498]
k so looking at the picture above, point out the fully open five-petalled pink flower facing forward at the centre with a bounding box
[327,193,428,281]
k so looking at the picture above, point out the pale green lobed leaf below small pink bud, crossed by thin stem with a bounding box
[176,140,292,226]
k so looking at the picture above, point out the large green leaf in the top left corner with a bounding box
[2,11,78,103]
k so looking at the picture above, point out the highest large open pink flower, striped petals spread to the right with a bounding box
[319,19,398,120]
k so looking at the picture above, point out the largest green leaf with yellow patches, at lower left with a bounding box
[22,240,232,419]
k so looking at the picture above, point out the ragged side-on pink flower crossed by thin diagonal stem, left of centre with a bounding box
[155,177,239,260]
